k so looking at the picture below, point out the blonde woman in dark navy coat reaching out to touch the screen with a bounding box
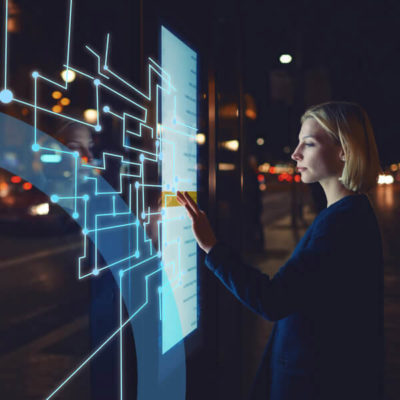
[177,102,383,400]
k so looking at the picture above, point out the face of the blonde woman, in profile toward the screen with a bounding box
[292,118,344,183]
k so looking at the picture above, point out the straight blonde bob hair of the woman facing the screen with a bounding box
[301,101,382,193]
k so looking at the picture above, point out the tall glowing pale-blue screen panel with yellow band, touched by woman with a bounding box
[161,27,198,354]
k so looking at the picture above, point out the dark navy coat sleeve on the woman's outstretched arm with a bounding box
[206,223,344,321]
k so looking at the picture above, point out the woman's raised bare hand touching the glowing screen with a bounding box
[176,191,217,253]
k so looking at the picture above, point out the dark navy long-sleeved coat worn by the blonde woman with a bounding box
[206,194,384,400]
